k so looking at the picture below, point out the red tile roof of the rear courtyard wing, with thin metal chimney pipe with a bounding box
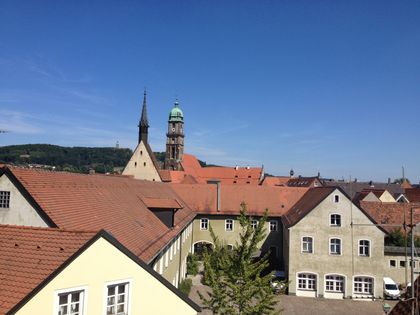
[172,184,307,216]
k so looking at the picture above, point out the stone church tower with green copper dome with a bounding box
[165,100,184,171]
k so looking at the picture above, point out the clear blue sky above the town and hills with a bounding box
[0,0,420,183]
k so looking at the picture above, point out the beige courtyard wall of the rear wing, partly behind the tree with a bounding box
[193,215,283,268]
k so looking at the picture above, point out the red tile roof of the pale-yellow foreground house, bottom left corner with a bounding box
[0,225,97,314]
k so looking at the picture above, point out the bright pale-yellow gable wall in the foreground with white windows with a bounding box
[17,238,197,315]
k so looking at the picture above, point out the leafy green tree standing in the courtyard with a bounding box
[198,203,278,315]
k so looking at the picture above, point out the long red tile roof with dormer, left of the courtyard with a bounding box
[4,168,195,262]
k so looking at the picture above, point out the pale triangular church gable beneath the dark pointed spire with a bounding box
[122,141,161,182]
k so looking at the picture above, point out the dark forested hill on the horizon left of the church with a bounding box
[0,144,133,173]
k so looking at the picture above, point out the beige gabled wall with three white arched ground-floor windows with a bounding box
[286,190,385,297]
